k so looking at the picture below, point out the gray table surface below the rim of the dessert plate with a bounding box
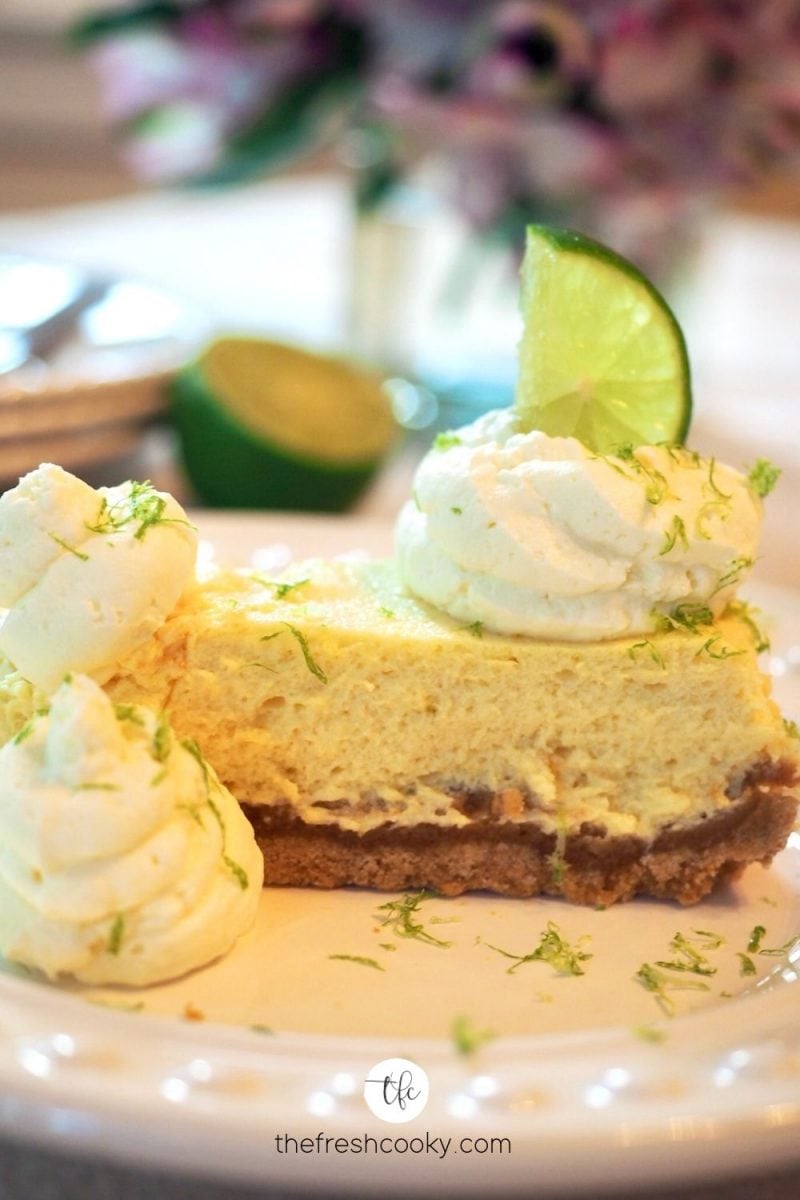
[0,1139,800,1200]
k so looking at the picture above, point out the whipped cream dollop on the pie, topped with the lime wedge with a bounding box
[396,410,762,641]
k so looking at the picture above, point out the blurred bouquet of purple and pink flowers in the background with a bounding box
[71,0,800,269]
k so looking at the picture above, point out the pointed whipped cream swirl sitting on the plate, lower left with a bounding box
[0,676,264,985]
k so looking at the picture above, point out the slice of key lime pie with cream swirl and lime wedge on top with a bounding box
[0,229,800,904]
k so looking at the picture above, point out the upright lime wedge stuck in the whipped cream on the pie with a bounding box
[515,226,692,454]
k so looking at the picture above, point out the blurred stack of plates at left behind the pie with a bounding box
[0,252,207,486]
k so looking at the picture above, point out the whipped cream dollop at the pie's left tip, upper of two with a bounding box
[0,463,197,692]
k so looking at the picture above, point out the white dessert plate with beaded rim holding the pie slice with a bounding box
[0,512,800,1196]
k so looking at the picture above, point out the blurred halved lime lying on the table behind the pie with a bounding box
[172,336,397,511]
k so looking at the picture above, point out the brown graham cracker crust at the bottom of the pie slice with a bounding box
[242,761,798,905]
